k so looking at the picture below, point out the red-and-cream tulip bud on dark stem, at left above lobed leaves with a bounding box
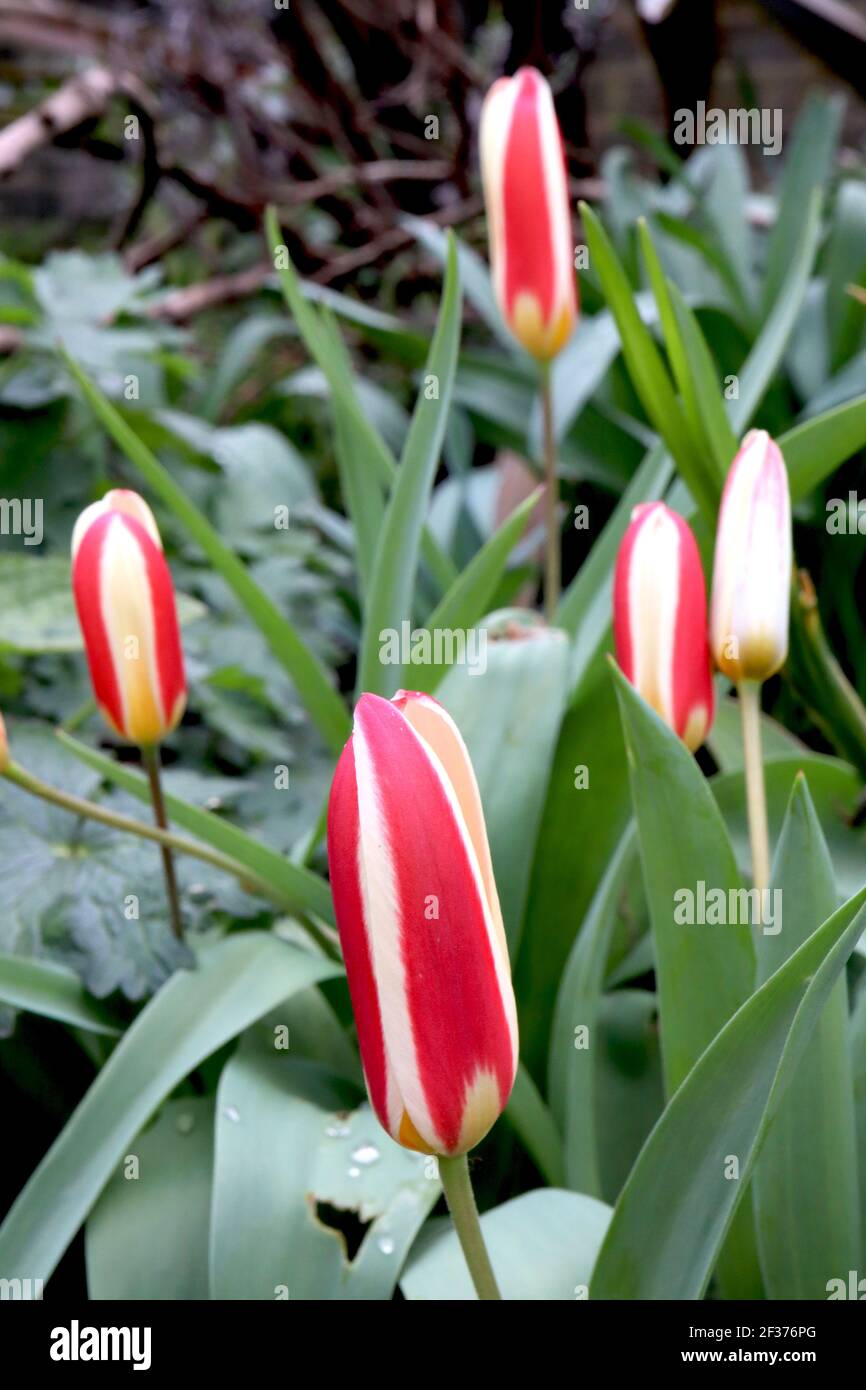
[72,489,186,745]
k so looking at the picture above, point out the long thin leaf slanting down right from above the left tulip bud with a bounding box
[63,353,352,752]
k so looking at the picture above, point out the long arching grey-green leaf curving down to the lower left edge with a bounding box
[0,931,339,1280]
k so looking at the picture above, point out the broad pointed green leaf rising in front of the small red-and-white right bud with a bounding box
[613,667,755,1095]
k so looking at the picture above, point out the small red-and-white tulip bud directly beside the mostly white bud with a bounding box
[613,502,713,752]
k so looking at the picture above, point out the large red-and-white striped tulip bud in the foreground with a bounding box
[328,691,517,1156]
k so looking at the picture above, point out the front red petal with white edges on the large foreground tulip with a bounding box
[346,695,516,1152]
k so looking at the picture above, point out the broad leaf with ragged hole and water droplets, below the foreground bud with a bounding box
[210,1026,439,1301]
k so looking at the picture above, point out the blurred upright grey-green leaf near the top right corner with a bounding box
[762,92,844,316]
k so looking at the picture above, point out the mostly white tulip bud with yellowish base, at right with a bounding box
[710,430,791,681]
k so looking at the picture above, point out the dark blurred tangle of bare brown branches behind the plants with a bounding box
[0,0,866,293]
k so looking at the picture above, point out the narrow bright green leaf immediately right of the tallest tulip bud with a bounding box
[580,203,714,512]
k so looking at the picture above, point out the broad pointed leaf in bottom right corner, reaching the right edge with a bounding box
[589,800,866,1300]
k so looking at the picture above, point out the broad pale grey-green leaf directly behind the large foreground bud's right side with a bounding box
[438,626,569,956]
